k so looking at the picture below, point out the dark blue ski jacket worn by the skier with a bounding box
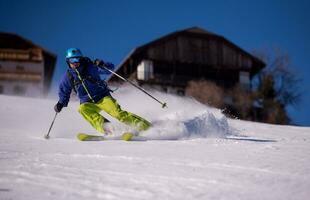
[58,59,114,107]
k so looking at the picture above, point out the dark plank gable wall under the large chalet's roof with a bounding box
[146,36,252,70]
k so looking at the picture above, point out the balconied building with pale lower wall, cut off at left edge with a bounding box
[0,32,56,96]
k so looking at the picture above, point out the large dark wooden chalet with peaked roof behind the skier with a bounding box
[110,27,265,94]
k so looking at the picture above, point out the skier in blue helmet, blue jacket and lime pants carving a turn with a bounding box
[54,48,151,134]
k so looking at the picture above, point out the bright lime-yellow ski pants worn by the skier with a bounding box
[79,96,151,133]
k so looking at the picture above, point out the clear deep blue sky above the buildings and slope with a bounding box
[0,0,310,126]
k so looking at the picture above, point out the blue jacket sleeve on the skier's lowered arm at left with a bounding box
[58,73,72,107]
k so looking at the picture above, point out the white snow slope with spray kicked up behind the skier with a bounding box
[0,87,310,200]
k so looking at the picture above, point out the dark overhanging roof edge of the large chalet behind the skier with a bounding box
[117,26,265,70]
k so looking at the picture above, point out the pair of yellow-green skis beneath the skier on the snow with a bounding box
[77,132,146,141]
